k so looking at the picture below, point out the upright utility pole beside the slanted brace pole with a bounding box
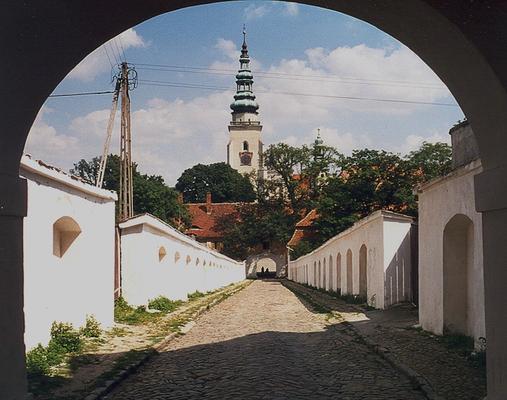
[118,62,134,220]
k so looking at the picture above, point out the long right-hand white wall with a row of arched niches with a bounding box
[289,211,415,309]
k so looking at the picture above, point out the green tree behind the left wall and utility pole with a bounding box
[70,154,190,228]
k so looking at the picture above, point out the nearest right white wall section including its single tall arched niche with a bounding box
[418,160,486,339]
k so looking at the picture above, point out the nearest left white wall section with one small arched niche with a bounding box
[20,156,116,349]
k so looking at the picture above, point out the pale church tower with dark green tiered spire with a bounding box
[227,27,264,178]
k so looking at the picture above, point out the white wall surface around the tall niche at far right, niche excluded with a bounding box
[419,161,485,339]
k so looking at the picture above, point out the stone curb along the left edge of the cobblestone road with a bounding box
[83,284,249,400]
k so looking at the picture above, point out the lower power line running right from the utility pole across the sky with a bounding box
[139,79,459,107]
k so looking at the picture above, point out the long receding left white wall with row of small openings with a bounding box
[119,214,245,306]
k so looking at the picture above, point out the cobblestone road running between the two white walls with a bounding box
[107,281,425,400]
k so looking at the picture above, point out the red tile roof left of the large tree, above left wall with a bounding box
[185,203,241,240]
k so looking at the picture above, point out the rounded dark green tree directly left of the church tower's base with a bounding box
[176,162,255,203]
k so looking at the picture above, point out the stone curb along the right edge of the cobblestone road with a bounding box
[282,281,445,400]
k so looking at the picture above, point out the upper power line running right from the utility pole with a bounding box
[135,63,445,89]
